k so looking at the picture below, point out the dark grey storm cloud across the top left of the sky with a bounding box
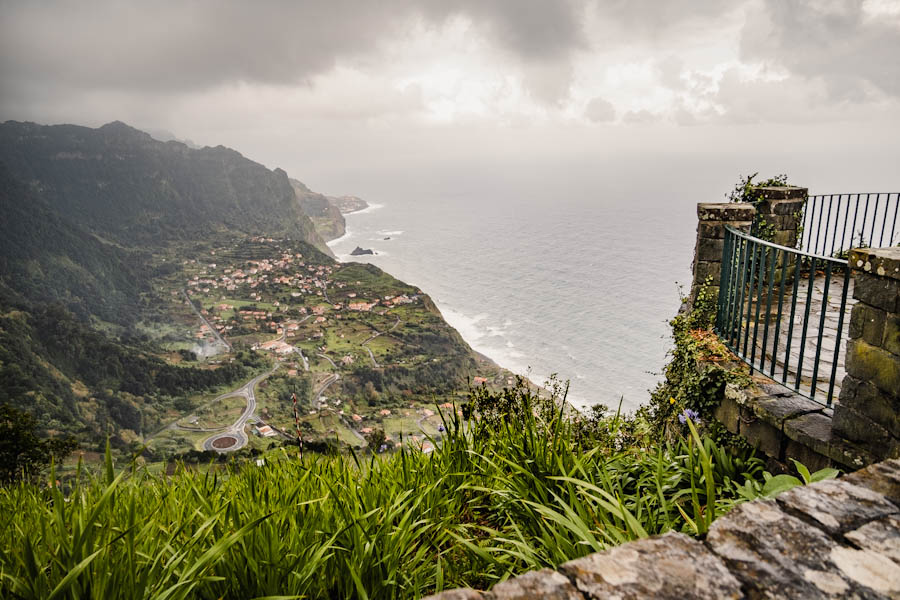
[0,0,583,91]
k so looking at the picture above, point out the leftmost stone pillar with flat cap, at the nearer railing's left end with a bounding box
[690,202,756,306]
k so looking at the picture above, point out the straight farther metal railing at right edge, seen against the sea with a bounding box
[799,193,900,256]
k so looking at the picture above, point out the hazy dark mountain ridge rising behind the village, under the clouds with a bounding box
[0,121,330,254]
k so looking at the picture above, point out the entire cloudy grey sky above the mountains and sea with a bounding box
[0,0,900,196]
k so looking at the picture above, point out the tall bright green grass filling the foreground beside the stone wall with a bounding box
[0,391,764,599]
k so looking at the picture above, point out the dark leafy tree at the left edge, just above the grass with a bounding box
[0,404,78,484]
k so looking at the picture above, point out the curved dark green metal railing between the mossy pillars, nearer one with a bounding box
[716,227,851,406]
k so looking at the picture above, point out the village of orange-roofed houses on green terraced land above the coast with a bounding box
[154,237,513,452]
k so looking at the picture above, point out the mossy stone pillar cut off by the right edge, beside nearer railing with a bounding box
[833,248,900,458]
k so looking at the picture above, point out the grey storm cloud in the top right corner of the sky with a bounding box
[741,0,900,101]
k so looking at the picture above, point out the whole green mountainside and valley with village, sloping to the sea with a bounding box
[0,122,506,460]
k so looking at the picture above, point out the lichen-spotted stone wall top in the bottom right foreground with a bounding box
[426,460,900,600]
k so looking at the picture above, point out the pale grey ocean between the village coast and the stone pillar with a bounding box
[329,184,696,411]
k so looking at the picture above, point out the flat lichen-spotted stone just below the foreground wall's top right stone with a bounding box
[777,479,900,535]
